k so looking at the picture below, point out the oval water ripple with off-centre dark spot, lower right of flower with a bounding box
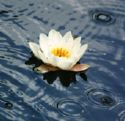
[86,89,116,108]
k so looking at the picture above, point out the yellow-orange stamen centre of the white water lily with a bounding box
[51,47,71,58]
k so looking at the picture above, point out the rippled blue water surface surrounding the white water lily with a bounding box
[0,0,125,121]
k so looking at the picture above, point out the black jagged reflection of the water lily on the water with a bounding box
[25,55,87,87]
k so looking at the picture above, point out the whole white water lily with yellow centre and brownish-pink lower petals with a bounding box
[29,29,89,73]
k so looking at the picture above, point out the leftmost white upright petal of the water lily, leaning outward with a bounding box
[29,42,40,59]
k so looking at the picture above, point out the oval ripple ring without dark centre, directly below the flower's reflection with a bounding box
[57,99,85,118]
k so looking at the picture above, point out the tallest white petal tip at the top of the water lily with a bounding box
[48,29,62,44]
